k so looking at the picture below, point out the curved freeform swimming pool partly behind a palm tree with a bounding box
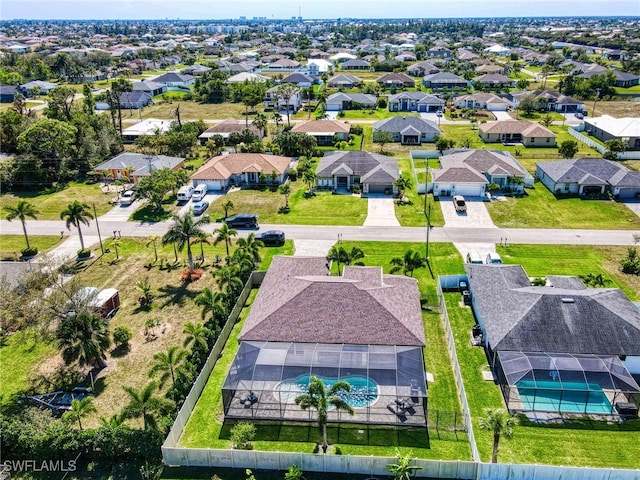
[273,375,378,408]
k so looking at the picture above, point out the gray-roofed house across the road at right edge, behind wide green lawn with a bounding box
[536,158,640,199]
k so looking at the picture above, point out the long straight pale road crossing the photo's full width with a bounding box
[0,219,636,245]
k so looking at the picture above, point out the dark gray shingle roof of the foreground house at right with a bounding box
[465,264,640,355]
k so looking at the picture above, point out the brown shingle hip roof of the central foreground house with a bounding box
[239,256,425,346]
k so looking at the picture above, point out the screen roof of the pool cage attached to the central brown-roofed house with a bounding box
[222,341,426,397]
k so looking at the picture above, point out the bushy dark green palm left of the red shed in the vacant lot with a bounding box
[56,310,111,368]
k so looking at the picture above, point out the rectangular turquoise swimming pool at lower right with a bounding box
[516,380,614,414]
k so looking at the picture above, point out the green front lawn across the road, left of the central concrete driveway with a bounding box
[209,179,367,225]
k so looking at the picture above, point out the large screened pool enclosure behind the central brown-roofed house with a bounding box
[222,341,427,427]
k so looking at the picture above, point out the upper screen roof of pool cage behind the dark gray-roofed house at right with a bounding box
[498,351,640,392]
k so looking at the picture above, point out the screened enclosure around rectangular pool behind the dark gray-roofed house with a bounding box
[494,351,640,415]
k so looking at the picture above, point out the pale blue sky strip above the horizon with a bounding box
[0,0,640,20]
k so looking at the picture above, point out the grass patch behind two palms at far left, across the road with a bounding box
[0,182,113,221]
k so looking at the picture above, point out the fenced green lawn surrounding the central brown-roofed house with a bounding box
[180,242,470,459]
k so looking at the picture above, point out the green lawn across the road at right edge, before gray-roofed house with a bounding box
[487,182,640,230]
